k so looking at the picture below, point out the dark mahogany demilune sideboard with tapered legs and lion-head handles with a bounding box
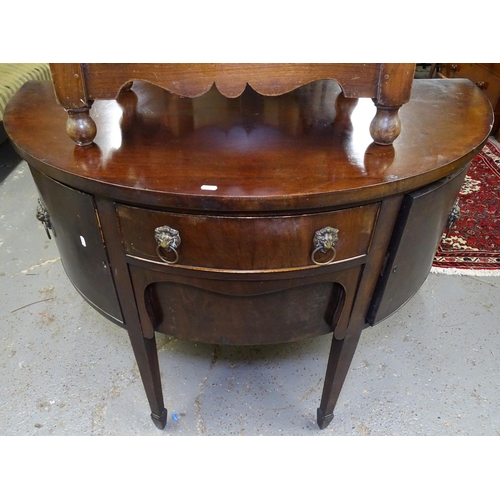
[4,74,493,428]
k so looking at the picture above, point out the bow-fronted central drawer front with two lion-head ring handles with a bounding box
[117,204,379,271]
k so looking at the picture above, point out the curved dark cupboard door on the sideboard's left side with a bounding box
[31,168,123,323]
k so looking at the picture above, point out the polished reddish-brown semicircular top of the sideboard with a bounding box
[4,79,493,212]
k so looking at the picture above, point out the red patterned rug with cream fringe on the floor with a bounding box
[432,140,500,276]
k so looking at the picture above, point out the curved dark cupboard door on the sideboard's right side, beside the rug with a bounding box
[367,168,467,326]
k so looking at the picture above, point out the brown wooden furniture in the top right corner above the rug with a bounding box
[434,63,500,140]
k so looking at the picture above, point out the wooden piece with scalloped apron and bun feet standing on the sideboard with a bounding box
[47,63,415,146]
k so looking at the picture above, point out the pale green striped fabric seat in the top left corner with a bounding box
[0,63,51,143]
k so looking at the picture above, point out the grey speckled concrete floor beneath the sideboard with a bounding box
[0,139,500,436]
